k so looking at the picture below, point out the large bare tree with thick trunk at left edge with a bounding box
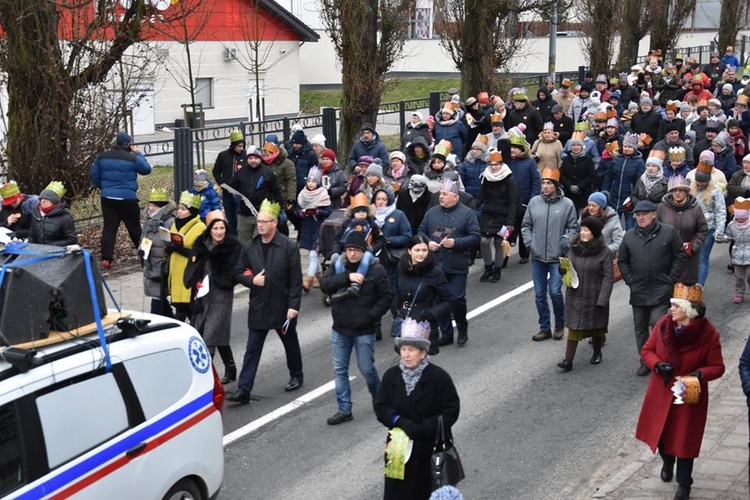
[0,0,191,196]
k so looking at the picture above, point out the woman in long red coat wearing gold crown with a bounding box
[635,283,724,500]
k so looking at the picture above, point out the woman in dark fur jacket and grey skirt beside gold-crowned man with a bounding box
[184,214,242,384]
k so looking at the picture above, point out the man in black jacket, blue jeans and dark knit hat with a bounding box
[320,231,392,425]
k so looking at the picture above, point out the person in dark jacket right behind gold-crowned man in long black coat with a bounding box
[228,146,284,243]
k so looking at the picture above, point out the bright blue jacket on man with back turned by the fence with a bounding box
[91,145,151,200]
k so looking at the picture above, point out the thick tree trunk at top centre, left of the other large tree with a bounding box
[336,0,381,172]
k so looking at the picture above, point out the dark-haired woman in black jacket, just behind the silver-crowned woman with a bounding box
[391,235,453,354]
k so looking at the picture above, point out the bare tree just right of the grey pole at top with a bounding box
[574,0,623,73]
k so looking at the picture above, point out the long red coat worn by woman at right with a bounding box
[635,314,724,458]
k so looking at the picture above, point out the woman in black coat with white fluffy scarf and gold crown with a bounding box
[476,151,518,283]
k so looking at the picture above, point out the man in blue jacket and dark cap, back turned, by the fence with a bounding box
[91,132,151,269]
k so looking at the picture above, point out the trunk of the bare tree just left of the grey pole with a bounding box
[461,0,495,99]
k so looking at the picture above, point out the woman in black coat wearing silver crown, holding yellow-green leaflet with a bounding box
[373,318,460,500]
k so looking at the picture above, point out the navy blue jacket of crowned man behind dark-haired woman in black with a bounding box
[419,203,482,274]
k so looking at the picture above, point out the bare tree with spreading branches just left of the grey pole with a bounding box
[435,0,554,96]
